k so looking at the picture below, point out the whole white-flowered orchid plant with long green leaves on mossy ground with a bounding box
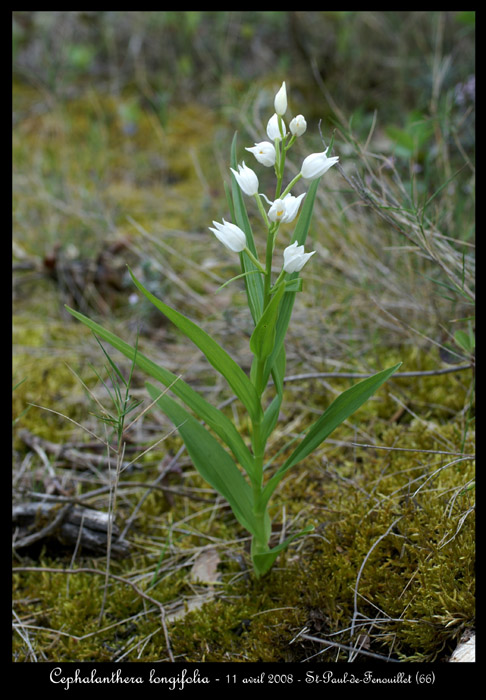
[69,82,400,577]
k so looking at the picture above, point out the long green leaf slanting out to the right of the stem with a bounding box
[264,362,402,502]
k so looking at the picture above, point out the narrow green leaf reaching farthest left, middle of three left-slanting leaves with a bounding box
[66,306,253,474]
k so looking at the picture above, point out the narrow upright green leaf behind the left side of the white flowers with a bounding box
[231,133,263,325]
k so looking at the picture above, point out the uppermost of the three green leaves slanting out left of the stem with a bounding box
[129,268,261,420]
